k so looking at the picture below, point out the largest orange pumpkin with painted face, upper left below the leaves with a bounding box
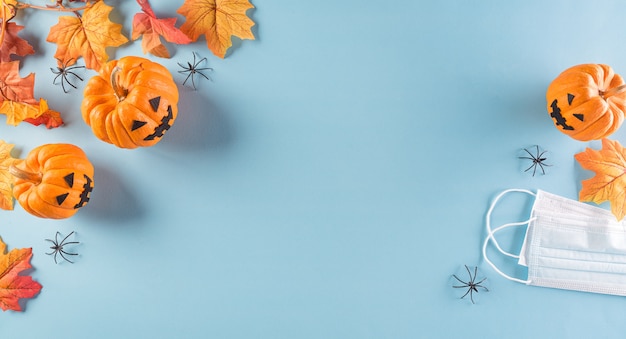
[81,56,178,148]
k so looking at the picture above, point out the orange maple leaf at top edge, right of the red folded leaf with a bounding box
[177,0,254,59]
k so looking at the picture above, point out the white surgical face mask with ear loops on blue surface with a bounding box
[482,189,626,296]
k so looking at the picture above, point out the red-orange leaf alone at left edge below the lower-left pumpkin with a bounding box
[0,239,41,311]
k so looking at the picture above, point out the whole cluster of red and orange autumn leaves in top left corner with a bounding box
[0,0,254,128]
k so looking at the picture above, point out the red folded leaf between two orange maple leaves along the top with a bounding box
[132,0,191,58]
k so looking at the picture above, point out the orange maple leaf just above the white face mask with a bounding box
[574,138,626,220]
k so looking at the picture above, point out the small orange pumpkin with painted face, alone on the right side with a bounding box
[546,64,626,141]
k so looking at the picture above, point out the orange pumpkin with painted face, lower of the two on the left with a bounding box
[9,144,93,219]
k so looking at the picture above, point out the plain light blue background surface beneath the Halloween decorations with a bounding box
[0,0,626,338]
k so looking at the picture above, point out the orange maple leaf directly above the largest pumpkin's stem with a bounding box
[46,1,128,71]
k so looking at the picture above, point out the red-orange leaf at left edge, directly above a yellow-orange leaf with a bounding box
[0,61,37,103]
